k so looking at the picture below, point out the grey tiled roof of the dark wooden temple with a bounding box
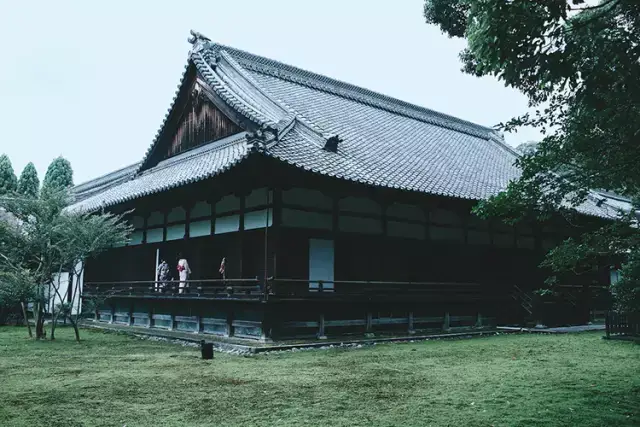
[67,36,628,219]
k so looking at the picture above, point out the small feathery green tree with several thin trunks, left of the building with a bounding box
[0,191,131,340]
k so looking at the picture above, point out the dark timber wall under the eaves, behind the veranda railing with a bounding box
[86,157,600,296]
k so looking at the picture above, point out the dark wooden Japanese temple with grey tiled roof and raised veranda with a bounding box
[70,33,615,340]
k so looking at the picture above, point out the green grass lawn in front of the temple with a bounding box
[0,327,640,427]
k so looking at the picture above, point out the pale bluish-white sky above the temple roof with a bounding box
[0,0,540,183]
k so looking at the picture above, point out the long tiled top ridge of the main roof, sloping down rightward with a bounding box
[208,43,494,138]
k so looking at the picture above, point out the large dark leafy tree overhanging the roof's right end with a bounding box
[424,0,640,308]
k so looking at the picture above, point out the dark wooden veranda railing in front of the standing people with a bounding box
[82,278,264,299]
